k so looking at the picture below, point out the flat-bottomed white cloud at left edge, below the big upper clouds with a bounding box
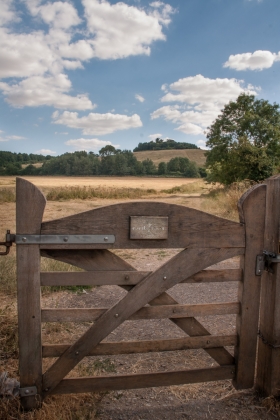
[0,74,96,110]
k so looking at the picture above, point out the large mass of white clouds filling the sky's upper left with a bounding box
[0,0,174,110]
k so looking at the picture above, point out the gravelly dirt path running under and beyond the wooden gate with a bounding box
[40,250,276,420]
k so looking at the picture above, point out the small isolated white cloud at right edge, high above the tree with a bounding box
[224,50,280,71]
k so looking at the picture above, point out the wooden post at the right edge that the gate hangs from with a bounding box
[256,176,280,395]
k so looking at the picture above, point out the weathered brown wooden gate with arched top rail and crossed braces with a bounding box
[12,178,280,409]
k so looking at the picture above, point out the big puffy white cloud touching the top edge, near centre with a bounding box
[82,0,173,60]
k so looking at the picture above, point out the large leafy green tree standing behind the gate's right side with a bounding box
[206,93,280,185]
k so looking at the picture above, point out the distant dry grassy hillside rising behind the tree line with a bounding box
[133,149,206,166]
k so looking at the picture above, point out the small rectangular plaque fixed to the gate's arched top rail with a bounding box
[130,216,168,239]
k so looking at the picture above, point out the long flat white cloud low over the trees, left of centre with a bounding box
[53,111,143,135]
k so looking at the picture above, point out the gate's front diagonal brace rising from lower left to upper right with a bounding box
[43,248,244,392]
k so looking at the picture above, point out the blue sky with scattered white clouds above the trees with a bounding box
[0,0,280,156]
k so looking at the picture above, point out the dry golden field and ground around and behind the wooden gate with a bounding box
[0,177,279,420]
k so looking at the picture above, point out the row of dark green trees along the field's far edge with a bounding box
[0,145,206,178]
